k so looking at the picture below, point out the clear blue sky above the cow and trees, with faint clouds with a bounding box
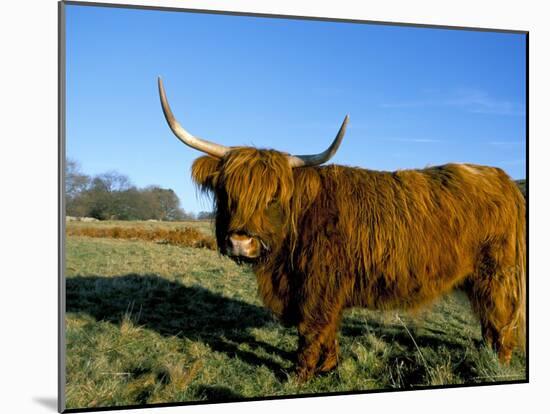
[66,5,526,212]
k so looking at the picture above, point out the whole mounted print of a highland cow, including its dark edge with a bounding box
[59,2,528,412]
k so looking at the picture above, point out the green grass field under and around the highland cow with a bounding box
[66,222,525,408]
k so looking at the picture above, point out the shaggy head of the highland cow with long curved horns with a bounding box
[158,78,348,261]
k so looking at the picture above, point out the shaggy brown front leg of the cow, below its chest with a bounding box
[296,304,342,382]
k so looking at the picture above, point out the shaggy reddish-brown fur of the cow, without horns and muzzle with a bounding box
[192,147,525,380]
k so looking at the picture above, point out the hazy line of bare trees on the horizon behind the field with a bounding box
[65,159,208,221]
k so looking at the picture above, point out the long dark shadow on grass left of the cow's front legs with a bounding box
[66,274,292,382]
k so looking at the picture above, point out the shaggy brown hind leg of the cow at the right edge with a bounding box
[466,239,523,363]
